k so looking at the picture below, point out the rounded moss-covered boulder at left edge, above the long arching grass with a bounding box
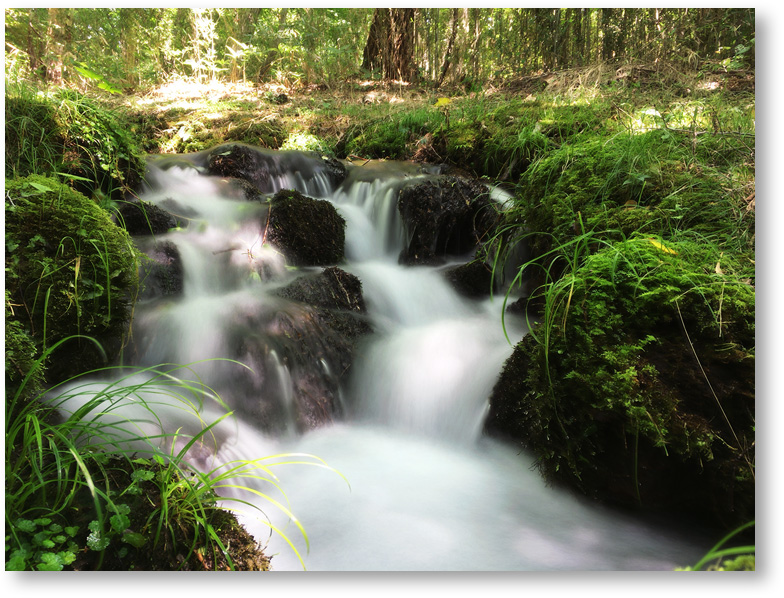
[5,176,138,381]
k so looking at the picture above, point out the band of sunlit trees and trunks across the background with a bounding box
[5,8,754,91]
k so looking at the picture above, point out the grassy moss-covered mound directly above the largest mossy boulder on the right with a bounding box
[510,131,753,262]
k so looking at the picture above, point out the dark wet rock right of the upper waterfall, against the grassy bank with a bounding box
[398,176,497,264]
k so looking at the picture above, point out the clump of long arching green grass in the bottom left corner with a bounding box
[5,352,344,570]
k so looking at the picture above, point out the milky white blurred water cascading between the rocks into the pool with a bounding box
[53,150,701,571]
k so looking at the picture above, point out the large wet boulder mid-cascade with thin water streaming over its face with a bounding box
[222,268,372,432]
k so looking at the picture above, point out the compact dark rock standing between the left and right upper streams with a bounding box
[266,190,346,266]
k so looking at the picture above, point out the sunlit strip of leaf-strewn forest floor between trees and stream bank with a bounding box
[107,59,755,169]
